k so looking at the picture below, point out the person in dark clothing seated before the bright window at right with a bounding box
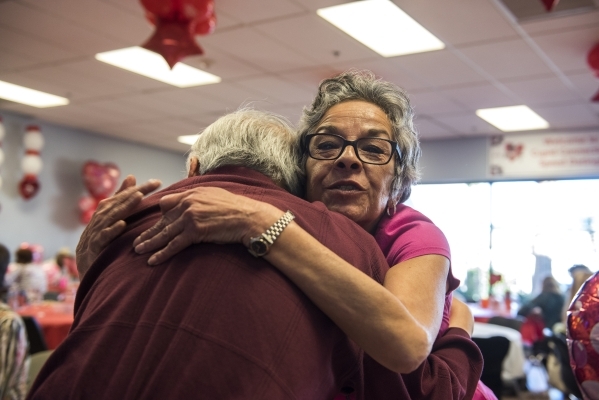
[518,276,564,329]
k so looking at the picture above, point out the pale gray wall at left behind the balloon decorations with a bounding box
[0,111,186,258]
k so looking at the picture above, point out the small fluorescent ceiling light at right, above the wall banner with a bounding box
[476,106,549,132]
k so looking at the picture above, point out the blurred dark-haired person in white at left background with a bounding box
[5,245,48,305]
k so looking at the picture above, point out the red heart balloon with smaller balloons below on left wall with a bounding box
[79,161,121,224]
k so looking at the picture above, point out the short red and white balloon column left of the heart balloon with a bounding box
[19,125,44,200]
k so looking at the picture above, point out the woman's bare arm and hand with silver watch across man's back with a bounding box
[134,187,449,373]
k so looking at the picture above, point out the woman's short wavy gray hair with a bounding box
[299,69,421,203]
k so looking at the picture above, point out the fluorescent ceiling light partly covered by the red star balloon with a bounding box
[96,46,221,88]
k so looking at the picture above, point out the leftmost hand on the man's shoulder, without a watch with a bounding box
[76,175,161,279]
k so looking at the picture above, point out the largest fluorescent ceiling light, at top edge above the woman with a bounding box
[316,0,445,57]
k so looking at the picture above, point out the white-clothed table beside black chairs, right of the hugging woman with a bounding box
[472,322,526,381]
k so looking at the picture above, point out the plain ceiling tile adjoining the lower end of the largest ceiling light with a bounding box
[389,50,485,87]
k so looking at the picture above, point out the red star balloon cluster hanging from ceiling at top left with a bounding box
[140,0,216,68]
